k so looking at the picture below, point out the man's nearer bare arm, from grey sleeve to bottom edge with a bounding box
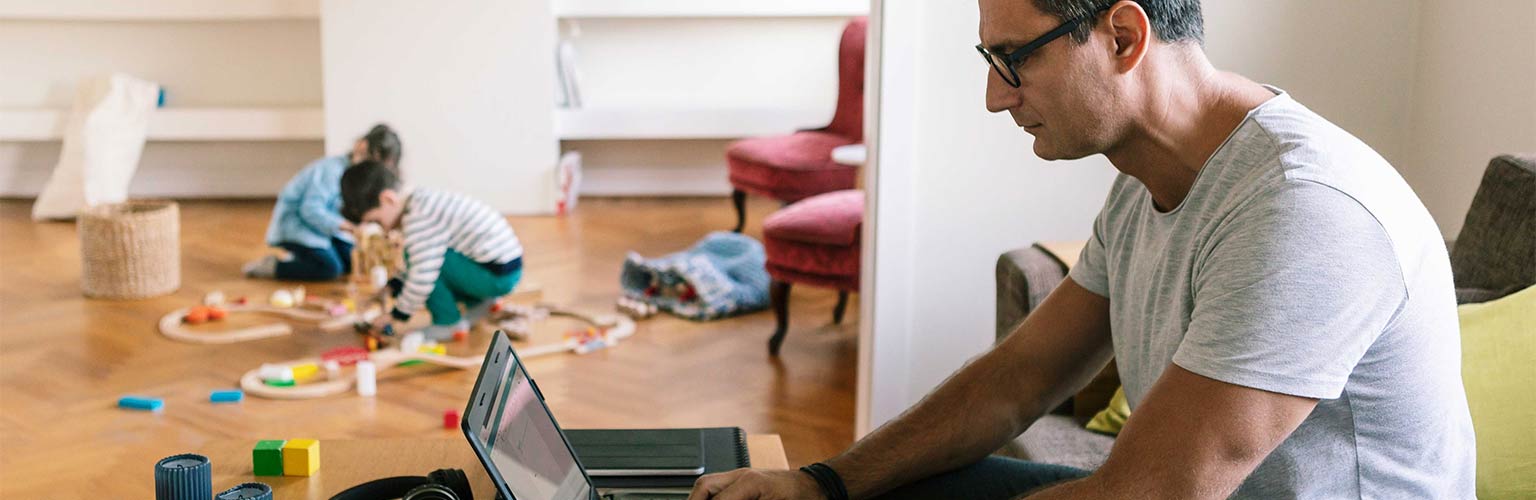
[1029,365,1318,500]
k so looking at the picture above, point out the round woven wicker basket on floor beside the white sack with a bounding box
[80,201,181,299]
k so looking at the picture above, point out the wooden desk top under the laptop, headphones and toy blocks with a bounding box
[109,434,790,500]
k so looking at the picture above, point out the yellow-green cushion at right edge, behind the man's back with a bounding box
[1458,287,1536,498]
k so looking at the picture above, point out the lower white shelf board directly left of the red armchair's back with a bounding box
[554,107,831,141]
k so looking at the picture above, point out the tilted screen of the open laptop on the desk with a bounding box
[481,348,593,500]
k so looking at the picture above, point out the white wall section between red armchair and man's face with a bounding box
[856,2,1114,436]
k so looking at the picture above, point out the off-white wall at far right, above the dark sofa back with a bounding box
[1396,0,1536,238]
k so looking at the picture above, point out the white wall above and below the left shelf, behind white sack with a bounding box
[0,15,323,198]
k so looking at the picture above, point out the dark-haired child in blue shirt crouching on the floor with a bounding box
[243,124,401,281]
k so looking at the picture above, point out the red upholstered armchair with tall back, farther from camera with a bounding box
[725,17,868,233]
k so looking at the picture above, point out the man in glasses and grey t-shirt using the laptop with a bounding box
[693,0,1476,500]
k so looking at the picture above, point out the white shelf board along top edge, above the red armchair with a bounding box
[554,0,869,18]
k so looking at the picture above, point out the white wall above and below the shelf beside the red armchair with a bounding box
[562,15,848,195]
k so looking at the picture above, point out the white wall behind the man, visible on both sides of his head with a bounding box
[859,0,1419,433]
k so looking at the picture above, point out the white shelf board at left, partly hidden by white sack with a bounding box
[0,107,326,141]
